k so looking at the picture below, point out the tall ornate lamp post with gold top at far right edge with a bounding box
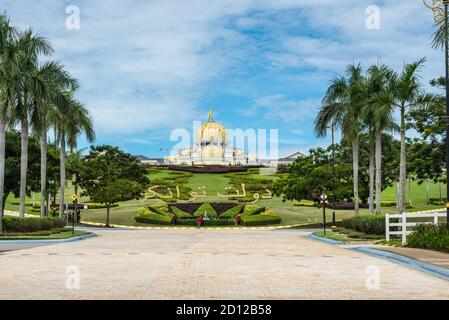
[423,0,449,227]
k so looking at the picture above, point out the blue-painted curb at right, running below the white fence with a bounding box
[350,247,449,281]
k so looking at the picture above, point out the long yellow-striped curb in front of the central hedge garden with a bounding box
[80,220,301,231]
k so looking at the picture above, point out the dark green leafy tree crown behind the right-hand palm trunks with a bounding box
[272,139,399,203]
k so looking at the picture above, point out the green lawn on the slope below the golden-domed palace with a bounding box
[6,169,446,225]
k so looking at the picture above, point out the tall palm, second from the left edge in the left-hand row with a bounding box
[13,29,53,218]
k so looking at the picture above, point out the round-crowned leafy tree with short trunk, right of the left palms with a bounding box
[80,146,150,226]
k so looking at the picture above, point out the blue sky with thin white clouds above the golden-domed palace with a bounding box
[0,0,444,157]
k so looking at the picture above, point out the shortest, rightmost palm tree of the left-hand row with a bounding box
[54,94,95,216]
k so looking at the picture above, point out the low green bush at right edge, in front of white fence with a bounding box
[407,225,449,252]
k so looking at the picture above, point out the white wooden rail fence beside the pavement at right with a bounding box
[385,212,446,245]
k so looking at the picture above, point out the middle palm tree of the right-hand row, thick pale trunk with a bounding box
[364,65,397,214]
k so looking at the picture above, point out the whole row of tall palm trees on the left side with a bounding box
[0,13,95,229]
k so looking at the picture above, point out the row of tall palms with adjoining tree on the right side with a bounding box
[315,59,445,214]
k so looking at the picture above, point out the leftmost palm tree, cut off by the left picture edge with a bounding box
[0,12,17,232]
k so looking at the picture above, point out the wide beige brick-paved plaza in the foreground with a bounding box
[0,230,449,300]
